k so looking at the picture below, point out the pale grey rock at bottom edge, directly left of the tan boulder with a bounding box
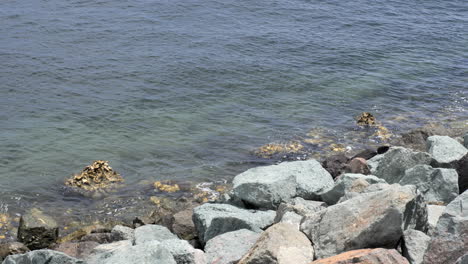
[205,229,260,264]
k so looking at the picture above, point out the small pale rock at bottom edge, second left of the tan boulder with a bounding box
[159,239,203,264]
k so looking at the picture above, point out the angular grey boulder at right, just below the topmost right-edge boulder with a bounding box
[399,165,458,204]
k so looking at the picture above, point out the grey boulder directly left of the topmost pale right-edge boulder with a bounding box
[368,147,432,184]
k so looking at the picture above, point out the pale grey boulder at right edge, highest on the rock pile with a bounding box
[427,136,468,165]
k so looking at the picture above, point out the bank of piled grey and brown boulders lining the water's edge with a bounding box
[0,127,468,264]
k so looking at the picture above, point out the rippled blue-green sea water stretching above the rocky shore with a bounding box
[0,0,468,223]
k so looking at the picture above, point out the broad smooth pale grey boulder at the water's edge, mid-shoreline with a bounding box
[233,160,333,209]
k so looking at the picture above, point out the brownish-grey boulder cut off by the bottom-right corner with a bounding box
[424,191,468,264]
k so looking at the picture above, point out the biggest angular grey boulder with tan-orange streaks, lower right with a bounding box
[301,184,427,258]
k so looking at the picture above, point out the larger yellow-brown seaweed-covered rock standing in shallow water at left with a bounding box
[65,160,124,192]
